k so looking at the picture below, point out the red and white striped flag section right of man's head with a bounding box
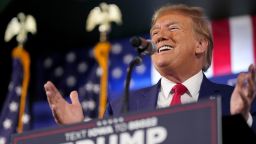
[208,15,256,77]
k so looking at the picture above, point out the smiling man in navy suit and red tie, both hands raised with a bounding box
[44,5,256,131]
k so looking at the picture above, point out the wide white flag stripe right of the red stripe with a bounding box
[229,16,254,73]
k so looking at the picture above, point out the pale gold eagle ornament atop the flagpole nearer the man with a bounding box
[86,2,122,41]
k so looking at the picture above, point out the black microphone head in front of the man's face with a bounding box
[130,36,157,55]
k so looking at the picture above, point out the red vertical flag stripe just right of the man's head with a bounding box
[212,20,231,76]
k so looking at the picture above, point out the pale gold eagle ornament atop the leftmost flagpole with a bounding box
[4,12,37,47]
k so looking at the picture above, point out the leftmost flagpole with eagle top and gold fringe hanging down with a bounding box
[4,12,37,137]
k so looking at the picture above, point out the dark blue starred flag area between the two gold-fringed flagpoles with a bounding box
[36,49,102,119]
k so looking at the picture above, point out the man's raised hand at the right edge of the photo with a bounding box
[230,64,256,120]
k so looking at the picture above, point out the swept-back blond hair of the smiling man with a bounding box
[151,4,213,71]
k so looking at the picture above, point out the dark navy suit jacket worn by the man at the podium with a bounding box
[105,75,256,132]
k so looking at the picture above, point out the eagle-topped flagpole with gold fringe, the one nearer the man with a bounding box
[86,2,122,118]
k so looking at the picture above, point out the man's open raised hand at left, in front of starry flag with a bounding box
[44,81,84,124]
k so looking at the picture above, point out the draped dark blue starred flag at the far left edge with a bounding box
[0,48,31,144]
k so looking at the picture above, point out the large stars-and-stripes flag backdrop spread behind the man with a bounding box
[35,15,256,127]
